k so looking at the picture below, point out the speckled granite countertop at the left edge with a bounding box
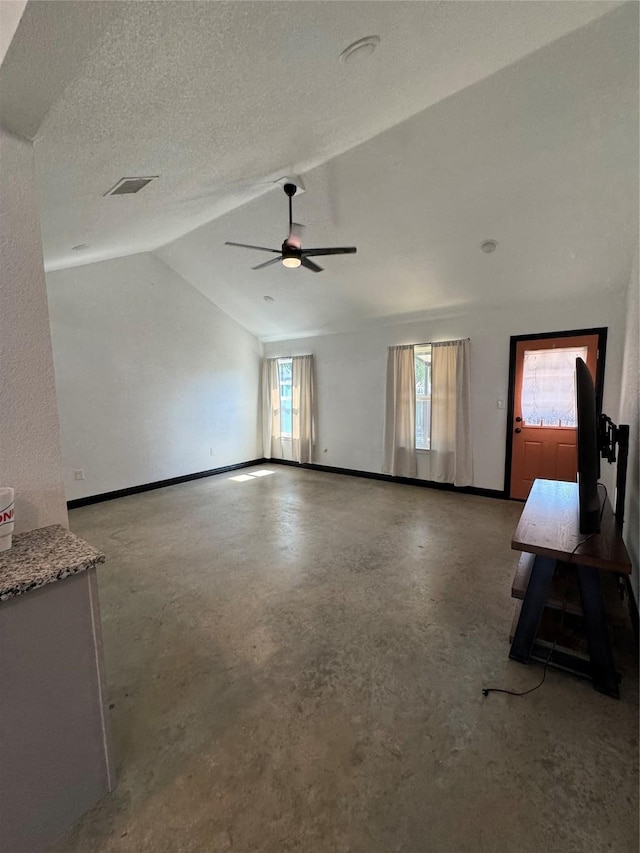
[0,524,105,601]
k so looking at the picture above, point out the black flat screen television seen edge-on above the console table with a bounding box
[576,358,600,533]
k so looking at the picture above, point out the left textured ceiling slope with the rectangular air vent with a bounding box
[3,0,612,268]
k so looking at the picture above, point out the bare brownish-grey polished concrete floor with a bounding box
[55,466,638,853]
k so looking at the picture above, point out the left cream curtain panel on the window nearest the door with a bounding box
[382,346,418,477]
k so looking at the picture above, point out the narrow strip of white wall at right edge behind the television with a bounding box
[618,252,640,602]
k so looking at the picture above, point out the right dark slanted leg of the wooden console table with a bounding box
[577,565,620,699]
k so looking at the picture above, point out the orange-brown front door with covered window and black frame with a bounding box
[510,334,599,499]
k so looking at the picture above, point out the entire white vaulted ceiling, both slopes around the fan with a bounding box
[0,0,638,339]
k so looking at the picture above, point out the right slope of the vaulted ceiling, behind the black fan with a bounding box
[158,8,638,339]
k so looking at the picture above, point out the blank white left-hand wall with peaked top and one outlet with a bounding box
[47,253,262,500]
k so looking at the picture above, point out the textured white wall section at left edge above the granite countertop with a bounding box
[0,131,67,533]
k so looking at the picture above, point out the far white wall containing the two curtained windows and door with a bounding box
[265,292,625,490]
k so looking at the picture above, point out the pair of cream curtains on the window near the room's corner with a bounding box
[261,355,315,462]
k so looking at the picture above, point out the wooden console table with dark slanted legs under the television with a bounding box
[509,480,631,698]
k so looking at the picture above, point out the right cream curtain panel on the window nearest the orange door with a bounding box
[430,340,473,486]
